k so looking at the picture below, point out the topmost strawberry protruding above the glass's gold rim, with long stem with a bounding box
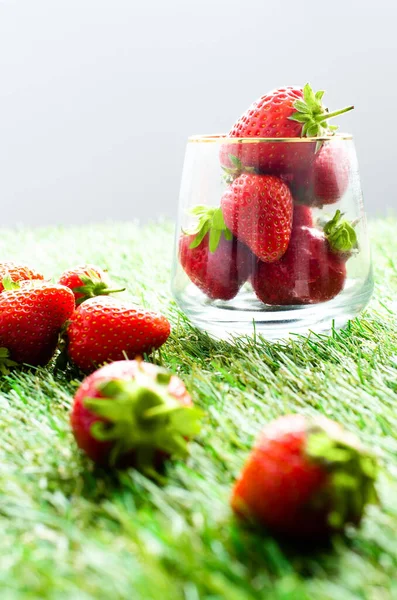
[220,84,354,174]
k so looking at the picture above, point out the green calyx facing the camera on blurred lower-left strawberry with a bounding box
[83,368,202,474]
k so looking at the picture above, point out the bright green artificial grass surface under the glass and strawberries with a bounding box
[0,220,397,600]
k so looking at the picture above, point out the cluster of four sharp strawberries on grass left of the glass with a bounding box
[0,262,170,373]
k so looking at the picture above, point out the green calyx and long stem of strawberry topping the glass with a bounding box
[288,83,354,137]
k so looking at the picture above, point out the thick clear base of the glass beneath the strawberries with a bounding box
[175,277,373,341]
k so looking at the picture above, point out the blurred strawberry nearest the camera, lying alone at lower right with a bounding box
[231,415,377,540]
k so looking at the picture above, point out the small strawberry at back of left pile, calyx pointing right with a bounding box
[59,265,125,305]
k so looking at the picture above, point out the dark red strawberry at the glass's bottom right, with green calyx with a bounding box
[251,206,357,305]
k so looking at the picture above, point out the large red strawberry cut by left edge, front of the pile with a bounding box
[0,280,74,365]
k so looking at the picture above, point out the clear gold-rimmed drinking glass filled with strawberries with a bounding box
[172,134,373,339]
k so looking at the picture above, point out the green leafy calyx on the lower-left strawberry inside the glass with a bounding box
[184,204,233,253]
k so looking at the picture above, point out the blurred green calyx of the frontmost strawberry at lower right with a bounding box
[305,419,378,530]
